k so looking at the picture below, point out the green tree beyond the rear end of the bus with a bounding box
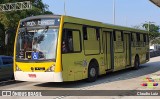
[143,23,160,44]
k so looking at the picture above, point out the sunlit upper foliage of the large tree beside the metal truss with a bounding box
[0,0,52,29]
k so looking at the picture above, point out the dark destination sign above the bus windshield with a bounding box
[21,18,60,27]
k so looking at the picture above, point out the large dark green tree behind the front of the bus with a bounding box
[0,0,53,55]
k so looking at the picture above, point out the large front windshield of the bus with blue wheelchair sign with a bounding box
[16,27,58,61]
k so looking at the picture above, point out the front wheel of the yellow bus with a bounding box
[87,62,98,82]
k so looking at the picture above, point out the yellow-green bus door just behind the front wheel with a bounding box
[103,31,112,71]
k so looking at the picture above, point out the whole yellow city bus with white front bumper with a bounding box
[14,15,150,82]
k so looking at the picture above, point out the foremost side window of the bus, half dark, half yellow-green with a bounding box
[62,29,81,53]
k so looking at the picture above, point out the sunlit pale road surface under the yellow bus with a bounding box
[0,57,160,99]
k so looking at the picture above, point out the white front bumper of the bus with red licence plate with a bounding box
[14,71,63,82]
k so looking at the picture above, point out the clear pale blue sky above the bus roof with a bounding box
[42,0,160,27]
